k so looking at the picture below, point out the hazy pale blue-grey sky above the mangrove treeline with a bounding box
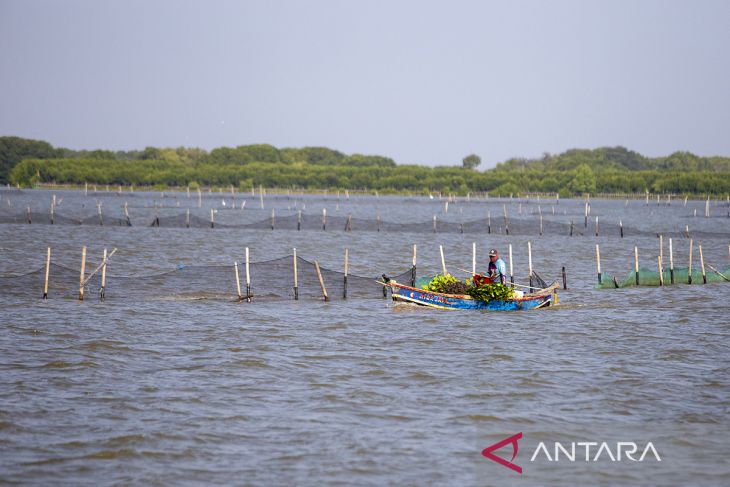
[0,0,730,169]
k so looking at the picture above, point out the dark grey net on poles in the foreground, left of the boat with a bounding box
[0,256,412,301]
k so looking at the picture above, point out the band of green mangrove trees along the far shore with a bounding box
[0,137,730,196]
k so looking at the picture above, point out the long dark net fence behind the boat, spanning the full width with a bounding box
[0,210,730,238]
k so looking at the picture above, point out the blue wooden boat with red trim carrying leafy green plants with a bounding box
[385,279,559,311]
